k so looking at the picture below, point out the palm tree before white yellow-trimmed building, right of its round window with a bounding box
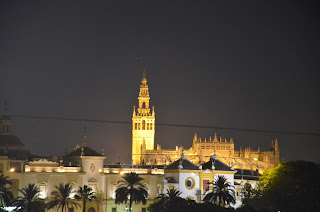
[203,176,236,207]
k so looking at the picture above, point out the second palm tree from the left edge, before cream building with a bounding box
[13,184,45,212]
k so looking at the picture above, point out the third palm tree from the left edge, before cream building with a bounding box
[47,183,80,212]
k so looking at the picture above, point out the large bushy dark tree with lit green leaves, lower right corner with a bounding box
[247,161,320,212]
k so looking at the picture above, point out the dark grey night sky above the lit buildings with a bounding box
[0,0,320,162]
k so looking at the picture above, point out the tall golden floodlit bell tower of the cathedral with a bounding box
[132,70,155,165]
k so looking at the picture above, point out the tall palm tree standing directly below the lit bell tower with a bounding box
[115,172,148,212]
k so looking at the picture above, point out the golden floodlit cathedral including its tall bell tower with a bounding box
[132,72,279,173]
